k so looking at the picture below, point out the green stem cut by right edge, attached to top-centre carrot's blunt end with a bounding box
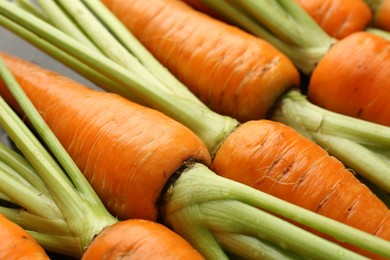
[271,90,390,192]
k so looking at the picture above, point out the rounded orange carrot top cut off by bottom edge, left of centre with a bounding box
[82,219,204,260]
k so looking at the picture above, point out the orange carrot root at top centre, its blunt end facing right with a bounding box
[103,0,299,122]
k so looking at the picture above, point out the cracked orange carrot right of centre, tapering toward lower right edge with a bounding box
[212,120,390,258]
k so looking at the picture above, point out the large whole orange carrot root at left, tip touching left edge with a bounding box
[0,54,211,220]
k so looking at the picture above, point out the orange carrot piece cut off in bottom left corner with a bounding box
[0,214,49,260]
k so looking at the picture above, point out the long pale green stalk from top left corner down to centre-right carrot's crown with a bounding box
[0,2,238,154]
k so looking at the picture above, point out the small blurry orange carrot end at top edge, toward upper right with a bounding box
[296,0,372,39]
